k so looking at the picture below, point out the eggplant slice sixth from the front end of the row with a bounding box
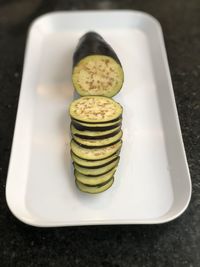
[72,130,122,147]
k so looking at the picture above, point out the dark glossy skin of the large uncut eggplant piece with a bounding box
[73,31,122,67]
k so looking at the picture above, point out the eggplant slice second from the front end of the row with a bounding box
[74,168,117,186]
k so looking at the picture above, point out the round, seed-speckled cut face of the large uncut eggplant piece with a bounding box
[72,55,123,97]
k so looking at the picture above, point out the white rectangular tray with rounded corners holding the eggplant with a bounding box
[6,11,191,226]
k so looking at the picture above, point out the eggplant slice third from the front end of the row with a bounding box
[74,158,119,176]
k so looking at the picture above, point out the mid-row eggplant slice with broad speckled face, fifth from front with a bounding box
[71,139,122,160]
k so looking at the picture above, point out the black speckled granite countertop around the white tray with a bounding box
[0,0,200,267]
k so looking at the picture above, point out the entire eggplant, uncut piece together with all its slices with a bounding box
[70,32,124,194]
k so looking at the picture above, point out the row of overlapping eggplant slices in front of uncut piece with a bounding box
[70,96,123,193]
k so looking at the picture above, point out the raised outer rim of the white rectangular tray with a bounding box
[5,9,192,227]
